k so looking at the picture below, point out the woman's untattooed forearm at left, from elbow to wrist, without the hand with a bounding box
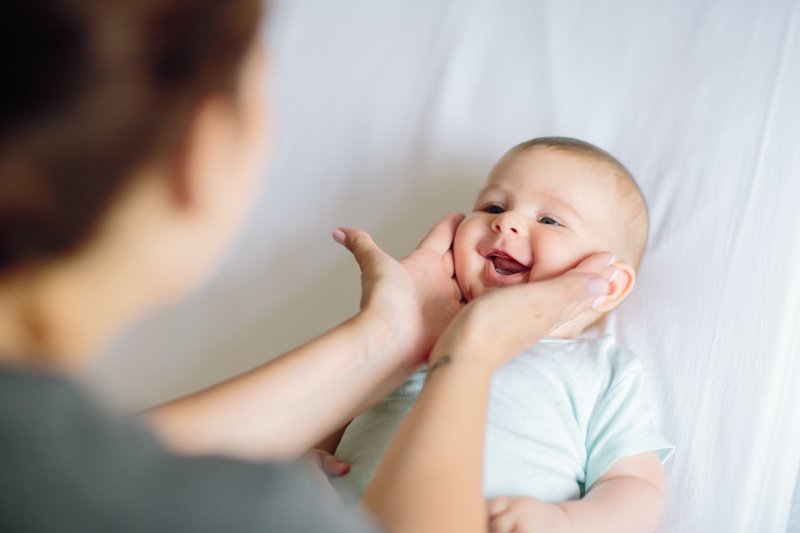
[146,314,414,459]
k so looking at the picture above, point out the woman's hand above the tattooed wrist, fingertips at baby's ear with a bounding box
[429,252,617,370]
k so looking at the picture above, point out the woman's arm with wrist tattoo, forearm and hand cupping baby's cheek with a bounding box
[363,253,616,532]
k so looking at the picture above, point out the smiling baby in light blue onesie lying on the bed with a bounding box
[334,138,673,531]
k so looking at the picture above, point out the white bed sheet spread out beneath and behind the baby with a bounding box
[91,0,800,533]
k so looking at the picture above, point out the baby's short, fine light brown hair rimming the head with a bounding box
[508,137,650,270]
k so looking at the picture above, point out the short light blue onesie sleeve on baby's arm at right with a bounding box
[585,345,675,491]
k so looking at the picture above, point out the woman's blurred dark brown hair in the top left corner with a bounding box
[0,0,262,274]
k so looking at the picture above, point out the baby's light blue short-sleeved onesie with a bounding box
[334,335,674,503]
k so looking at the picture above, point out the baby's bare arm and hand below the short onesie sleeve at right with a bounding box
[489,452,667,533]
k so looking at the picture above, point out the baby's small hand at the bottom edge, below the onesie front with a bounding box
[487,496,569,533]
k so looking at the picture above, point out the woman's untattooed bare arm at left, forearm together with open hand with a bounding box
[145,213,464,459]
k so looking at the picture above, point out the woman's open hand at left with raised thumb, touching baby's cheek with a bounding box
[333,213,464,367]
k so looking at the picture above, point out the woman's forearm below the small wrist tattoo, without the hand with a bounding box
[364,356,500,533]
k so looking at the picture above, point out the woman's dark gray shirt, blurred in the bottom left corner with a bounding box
[0,369,377,533]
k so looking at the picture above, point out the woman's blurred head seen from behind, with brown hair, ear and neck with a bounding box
[0,0,267,368]
